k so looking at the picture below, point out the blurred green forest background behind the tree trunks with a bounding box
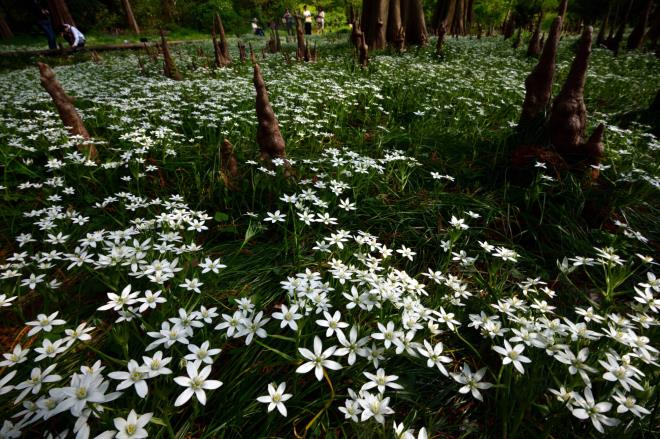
[0,0,644,42]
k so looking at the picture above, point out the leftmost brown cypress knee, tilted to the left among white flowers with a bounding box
[37,62,98,161]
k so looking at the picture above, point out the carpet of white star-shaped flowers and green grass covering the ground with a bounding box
[0,27,660,438]
